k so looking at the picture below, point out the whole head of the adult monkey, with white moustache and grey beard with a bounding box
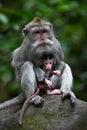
[23,17,56,59]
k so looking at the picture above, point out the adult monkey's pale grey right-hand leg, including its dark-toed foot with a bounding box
[60,64,76,103]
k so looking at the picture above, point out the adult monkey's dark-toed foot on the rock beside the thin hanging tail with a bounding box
[31,95,44,107]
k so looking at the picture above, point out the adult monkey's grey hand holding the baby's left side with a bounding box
[34,67,45,82]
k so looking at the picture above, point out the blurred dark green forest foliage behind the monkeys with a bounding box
[0,0,87,102]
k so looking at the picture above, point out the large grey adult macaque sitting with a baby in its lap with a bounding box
[12,17,76,107]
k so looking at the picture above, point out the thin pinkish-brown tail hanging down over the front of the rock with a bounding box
[19,88,39,125]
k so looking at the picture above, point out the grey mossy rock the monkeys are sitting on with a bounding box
[0,95,87,130]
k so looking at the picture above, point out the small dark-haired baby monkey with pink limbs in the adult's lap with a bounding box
[38,55,62,95]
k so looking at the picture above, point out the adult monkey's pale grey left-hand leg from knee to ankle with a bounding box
[21,61,37,98]
